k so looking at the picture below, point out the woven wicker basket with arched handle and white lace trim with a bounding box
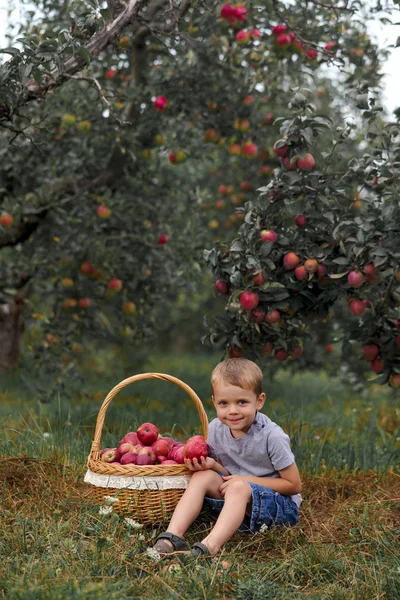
[85,373,208,524]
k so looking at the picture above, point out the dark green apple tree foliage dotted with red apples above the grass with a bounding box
[0,0,399,393]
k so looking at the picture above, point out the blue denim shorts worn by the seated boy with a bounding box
[204,482,299,533]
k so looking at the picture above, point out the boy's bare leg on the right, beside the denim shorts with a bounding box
[202,481,252,554]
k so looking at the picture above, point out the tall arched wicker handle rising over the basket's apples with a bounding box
[91,373,208,455]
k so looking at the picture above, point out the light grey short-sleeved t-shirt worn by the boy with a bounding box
[207,413,302,506]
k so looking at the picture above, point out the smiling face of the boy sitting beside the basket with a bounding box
[212,382,265,438]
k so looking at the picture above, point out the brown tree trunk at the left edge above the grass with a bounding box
[0,294,23,373]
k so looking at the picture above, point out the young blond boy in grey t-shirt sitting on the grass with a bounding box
[154,358,301,556]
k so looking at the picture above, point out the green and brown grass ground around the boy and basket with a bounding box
[0,355,400,600]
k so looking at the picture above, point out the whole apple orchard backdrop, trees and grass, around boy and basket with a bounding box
[0,0,400,599]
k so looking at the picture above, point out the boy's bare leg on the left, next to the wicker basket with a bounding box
[158,469,222,544]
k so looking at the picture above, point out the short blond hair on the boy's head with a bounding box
[211,358,262,396]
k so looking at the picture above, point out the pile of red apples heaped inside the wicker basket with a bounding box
[100,423,210,466]
